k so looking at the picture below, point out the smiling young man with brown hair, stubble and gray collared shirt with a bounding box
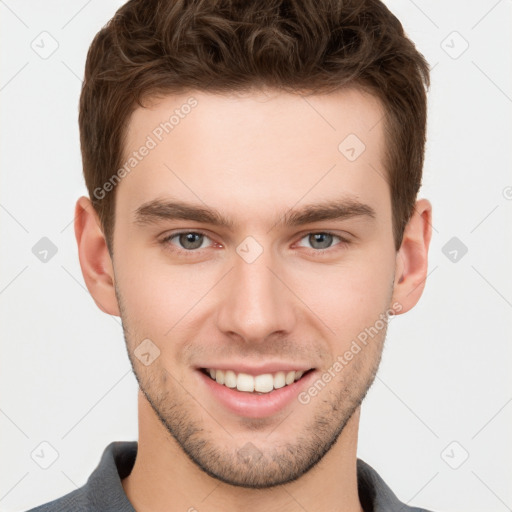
[27,0,432,512]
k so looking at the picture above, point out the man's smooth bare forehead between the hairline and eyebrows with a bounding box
[117,89,389,220]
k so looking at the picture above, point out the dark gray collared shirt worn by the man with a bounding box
[23,441,429,512]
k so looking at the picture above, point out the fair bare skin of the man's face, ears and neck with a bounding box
[75,89,432,512]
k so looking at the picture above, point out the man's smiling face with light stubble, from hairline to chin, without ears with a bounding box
[113,90,400,488]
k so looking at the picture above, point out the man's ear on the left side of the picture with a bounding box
[75,196,120,316]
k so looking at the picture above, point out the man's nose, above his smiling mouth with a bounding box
[217,244,297,343]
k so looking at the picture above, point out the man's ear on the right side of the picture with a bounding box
[392,199,432,314]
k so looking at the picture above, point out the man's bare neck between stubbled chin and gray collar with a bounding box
[122,391,363,512]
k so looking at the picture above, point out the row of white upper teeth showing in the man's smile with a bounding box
[206,368,304,393]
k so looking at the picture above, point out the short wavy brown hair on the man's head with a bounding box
[79,0,430,254]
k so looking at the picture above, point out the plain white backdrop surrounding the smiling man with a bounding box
[0,0,512,512]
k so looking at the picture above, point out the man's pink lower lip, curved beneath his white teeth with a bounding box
[197,370,316,418]
